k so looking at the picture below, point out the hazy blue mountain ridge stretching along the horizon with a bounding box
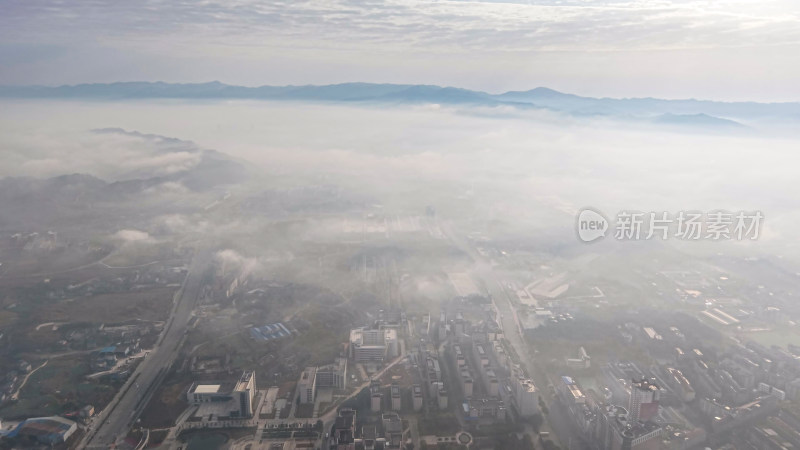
[0,81,800,126]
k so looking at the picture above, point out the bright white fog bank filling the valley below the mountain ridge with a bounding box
[0,101,800,243]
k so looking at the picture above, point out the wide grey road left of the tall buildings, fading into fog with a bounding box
[78,249,212,449]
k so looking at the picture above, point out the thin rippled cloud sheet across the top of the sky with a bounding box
[3,0,800,52]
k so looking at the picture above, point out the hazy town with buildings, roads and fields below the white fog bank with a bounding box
[0,125,800,450]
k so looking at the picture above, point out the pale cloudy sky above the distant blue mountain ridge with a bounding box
[0,0,800,101]
